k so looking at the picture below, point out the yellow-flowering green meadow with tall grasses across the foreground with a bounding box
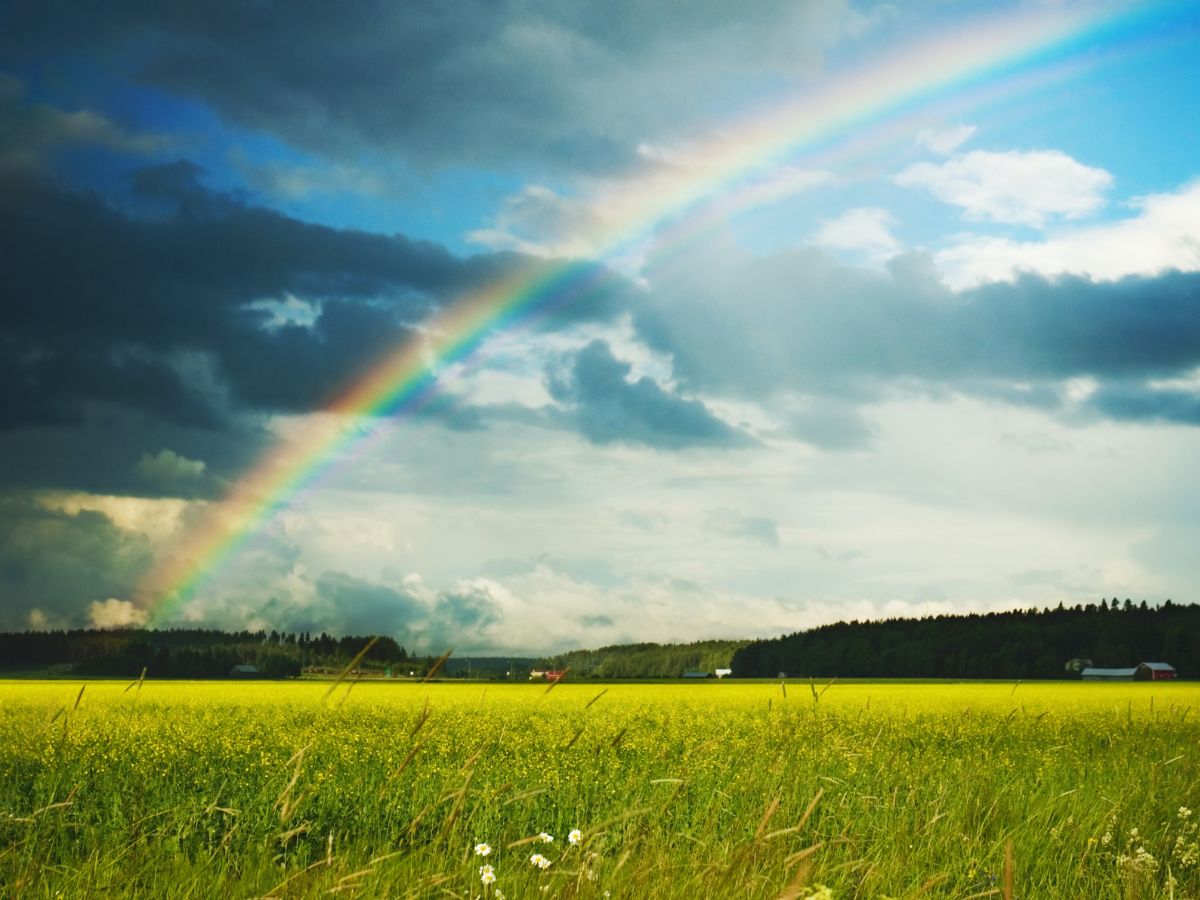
[0,680,1200,900]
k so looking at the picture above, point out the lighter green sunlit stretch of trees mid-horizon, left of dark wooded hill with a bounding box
[546,641,745,678]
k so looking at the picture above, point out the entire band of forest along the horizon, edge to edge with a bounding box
[0,598,1200,680]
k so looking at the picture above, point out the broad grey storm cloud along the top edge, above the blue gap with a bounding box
[0,0,844,176]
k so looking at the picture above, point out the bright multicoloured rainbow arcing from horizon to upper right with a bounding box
[134,5,1168,624]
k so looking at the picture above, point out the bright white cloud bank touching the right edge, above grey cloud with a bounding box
[936,180,1200,289]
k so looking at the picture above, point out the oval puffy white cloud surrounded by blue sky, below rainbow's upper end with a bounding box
[895,150,1112,228]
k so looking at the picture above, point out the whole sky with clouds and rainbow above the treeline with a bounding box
[0,0,1200,655]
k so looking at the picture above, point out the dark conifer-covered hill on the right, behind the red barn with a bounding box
[732,598,1200,678]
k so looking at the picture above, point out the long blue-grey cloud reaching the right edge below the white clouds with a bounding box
[636,251,1200,427]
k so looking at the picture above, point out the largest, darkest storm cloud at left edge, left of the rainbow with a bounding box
[0,162,619,484]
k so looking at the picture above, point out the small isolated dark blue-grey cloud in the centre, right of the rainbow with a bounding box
[548,341,748,449]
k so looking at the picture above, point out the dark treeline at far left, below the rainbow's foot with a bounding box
[0,629,412,678]
